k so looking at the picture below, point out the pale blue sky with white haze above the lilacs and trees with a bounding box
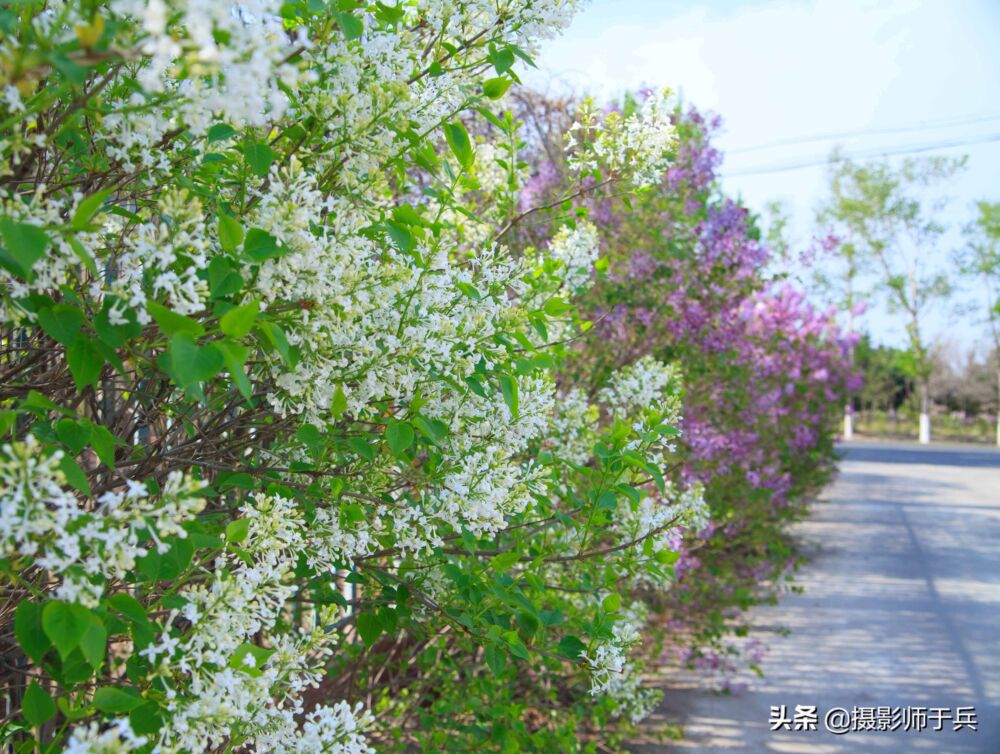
[528,0,1000,347]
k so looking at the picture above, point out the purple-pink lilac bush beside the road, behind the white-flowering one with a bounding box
[520,92,858,682]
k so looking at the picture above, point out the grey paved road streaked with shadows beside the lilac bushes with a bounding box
[634,442,1000,754]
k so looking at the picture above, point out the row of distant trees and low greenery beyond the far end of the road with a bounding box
[796,152,1000,445]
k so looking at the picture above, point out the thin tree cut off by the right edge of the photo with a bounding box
[959,201,1000,446]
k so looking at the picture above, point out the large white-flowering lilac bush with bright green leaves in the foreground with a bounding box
[0,0,852,754]
